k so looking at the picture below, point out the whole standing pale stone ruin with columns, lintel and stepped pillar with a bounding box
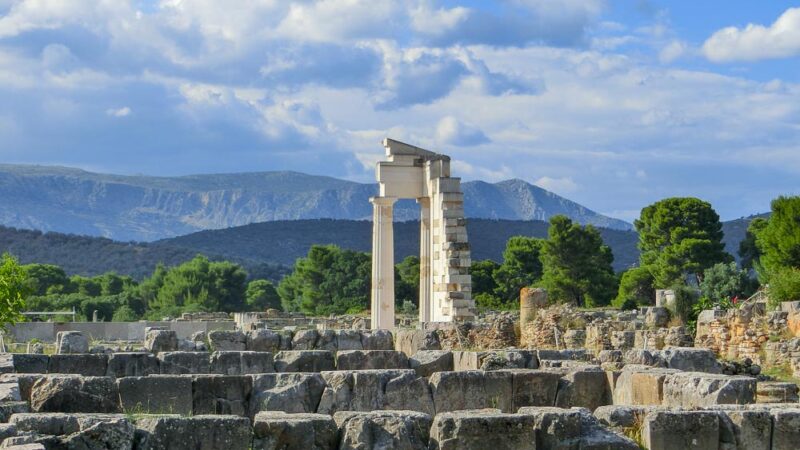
[370,138,475,330]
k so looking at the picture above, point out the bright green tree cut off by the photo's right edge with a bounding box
[756,196,800,283]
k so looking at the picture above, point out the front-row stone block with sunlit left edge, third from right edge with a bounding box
[642,411,720,450]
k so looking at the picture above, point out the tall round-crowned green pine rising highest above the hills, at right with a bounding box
[634,198,733,288]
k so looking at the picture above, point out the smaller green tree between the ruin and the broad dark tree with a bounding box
[492,236,544,304]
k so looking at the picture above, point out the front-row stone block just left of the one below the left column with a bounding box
[252,411,338,450]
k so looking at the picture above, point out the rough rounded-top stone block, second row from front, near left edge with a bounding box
[31,375,119,413]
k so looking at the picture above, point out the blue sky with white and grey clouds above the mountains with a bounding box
[0,0,800,221]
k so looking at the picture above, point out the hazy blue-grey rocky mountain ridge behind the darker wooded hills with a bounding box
[0,164,631,241]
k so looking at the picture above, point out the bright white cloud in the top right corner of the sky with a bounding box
[703,8,800,62]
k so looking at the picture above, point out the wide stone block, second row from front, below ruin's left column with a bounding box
[317,369,434,414]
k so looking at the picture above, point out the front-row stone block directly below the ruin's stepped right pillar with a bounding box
[430,409,540,450]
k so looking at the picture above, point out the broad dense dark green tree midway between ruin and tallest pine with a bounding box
[541,215,617,306]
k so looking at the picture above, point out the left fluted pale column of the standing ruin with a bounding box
[369,197,397,330]
